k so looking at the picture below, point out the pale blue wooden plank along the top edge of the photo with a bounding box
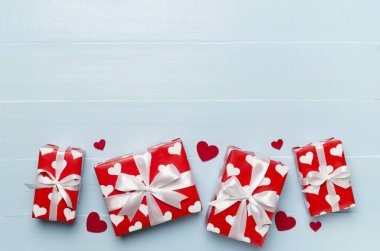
[0,0,380,42]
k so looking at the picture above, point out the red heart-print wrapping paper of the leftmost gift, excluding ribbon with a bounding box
[32,144,84,223]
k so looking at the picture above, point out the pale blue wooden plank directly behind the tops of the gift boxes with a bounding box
[0,102,380,159]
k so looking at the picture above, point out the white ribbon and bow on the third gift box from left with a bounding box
[210,157,278,241]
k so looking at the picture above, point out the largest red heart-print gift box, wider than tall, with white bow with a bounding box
[95,139,202,236]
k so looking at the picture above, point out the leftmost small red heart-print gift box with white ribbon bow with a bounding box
[27,145,84,223]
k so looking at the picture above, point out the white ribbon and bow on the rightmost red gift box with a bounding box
[302,145,351,212]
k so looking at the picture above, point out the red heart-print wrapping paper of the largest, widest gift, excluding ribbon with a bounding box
[95,139,201,236]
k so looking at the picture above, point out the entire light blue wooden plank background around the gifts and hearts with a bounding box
[0,0,380,251]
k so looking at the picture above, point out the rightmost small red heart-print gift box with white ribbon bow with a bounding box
[293,138,355,217]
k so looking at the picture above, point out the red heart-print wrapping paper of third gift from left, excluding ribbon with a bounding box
[206,147,288,246]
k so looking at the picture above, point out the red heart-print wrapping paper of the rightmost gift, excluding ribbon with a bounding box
[293,138,355,217]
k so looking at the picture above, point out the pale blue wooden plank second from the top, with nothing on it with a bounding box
[0,43,380,102]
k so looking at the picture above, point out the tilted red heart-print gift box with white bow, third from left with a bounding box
[206,147,288,246]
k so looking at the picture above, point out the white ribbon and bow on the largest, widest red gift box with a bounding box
[105,152,194,226]
